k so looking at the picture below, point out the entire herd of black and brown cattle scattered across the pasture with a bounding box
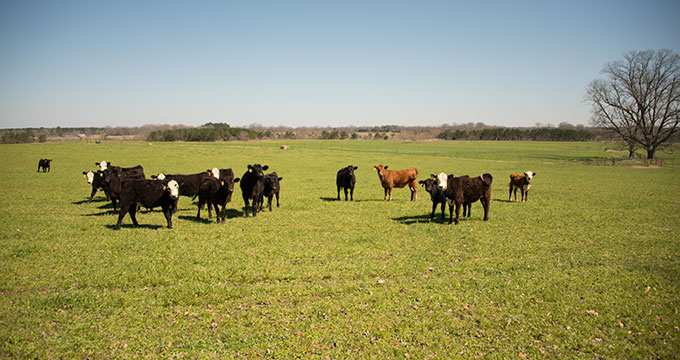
[65,159,536,230]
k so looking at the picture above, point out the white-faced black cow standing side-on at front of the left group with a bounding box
[116,179,179,230]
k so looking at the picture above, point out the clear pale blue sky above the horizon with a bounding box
[0,0,680,128]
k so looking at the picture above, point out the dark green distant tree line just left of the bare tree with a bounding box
[437,127,595,141]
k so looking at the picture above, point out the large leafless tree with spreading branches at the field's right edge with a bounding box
[587,49,680,159]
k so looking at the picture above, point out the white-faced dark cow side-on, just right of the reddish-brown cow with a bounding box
[437,174,493,225]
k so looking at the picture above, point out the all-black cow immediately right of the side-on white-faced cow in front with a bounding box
[196,169,240,224]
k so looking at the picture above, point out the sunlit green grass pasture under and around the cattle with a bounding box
[0,141,680,359]
